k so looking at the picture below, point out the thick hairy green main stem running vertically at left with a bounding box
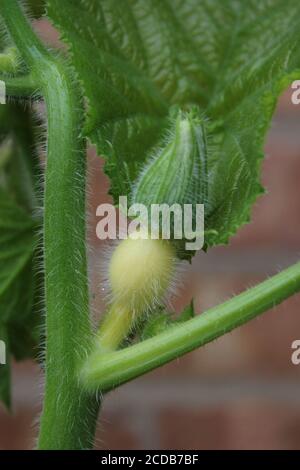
[0,0,99,449]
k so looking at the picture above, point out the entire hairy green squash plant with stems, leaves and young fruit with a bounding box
[0,0,300,449]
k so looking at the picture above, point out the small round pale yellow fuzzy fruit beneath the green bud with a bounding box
[98,232,176,351]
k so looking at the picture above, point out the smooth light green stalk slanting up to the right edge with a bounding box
[81,263,300,391]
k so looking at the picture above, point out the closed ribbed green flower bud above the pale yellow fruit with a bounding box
[132,107,208,221]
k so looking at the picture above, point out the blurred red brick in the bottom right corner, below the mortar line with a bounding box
[161,401,300,450]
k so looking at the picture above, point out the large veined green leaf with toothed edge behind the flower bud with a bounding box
[48,0,300,246]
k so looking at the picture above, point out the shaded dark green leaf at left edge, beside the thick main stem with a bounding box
[0,189,40,407]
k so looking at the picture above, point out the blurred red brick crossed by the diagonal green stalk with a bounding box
[143,275,300,378]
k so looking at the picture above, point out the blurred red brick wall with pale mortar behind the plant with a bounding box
[0,20,300,450]
